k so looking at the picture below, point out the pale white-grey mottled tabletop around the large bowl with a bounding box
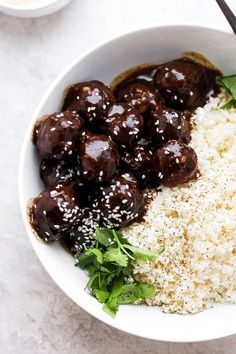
[0,0,236,354]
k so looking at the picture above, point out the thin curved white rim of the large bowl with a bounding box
[18,23,236,343]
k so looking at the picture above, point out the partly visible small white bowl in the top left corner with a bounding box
[0,0,71,17]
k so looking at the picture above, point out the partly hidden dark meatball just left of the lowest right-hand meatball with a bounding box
[122,141,159,187]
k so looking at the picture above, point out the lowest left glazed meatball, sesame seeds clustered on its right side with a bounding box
[30,186,79,241]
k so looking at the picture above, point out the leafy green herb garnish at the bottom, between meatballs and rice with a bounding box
[76,228,163,317]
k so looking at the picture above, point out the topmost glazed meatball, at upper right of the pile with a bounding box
[155,60,206,109]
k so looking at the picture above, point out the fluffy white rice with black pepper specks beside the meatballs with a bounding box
[124,95,236,314]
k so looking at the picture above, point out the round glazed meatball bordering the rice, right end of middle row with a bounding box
[154,140,198,187]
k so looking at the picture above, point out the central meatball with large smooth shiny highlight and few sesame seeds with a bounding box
[80,134,119,182]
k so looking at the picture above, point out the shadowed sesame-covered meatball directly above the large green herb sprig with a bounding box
[64,208,99,254]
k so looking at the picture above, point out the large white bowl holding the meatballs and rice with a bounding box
[19,26,236,342]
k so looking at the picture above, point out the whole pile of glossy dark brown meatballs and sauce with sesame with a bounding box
[29,52,221,254]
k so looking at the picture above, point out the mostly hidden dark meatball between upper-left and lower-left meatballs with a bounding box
[40,159,81,187]
